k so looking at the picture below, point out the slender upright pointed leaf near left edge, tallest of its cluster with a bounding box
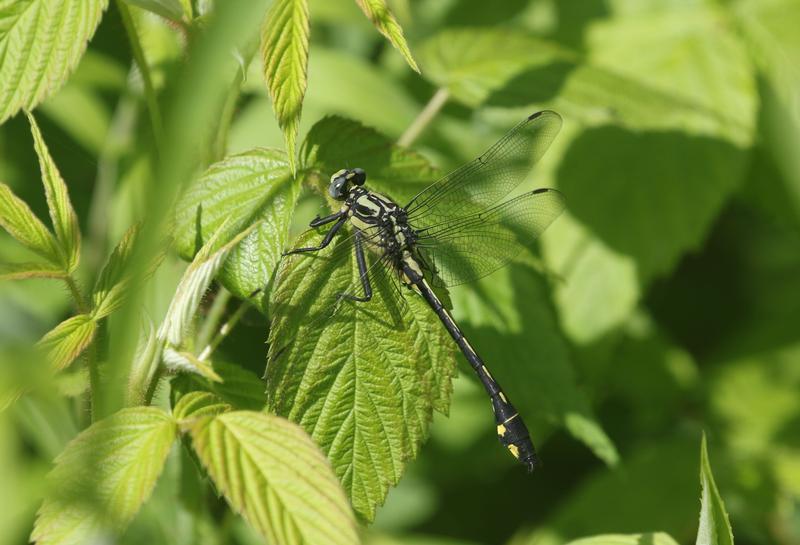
[27,114,81,273]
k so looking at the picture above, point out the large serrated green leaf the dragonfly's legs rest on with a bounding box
[265,228,456,520]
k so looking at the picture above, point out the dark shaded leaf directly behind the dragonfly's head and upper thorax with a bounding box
[300,116,439,208]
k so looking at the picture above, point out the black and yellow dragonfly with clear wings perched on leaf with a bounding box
[284,110,565,471]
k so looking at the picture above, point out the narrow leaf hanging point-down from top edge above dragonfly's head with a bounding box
[261,0,309,172]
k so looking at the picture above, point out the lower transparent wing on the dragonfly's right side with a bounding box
[412,189,564,286]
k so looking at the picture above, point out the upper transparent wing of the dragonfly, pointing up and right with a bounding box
[405,110,561,228]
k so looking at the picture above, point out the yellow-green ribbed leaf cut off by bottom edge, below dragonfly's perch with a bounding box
[190,411,359,545]
